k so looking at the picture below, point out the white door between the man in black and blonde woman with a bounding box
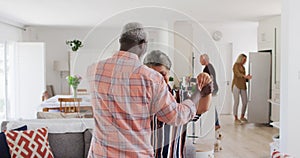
[216,43,232,114]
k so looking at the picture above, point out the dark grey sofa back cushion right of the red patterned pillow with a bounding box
[49,132,84,158]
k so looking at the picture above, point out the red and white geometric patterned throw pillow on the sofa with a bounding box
[5,128,53,158]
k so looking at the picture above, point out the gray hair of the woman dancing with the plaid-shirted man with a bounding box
[144,50,172,70]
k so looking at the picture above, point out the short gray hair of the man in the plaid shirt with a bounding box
[120,22,147,44]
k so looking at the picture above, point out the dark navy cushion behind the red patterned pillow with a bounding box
[0,125,27,158]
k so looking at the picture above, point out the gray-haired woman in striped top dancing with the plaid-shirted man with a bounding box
[144,50,210,158]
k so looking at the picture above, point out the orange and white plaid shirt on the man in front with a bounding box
[88,51,196,158]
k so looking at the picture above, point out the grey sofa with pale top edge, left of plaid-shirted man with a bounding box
[0,118,94,158]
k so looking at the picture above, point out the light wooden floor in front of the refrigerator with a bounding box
[214,115,279,158]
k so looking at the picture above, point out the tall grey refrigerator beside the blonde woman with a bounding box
[248,52,272,123]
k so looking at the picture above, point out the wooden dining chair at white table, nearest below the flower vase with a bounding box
[58,98,82,113]
